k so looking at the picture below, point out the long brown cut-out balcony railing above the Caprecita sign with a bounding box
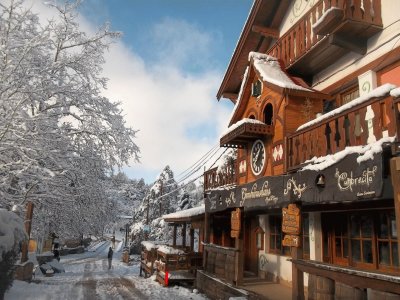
[286,90,400,171]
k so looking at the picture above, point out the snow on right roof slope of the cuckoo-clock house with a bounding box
[249,52,313,92]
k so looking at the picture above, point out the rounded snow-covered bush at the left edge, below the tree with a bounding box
[0,208,26,261]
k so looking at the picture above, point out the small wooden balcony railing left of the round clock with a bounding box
[204,160,237,191]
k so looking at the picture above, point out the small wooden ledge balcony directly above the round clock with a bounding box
[219,122,274,148]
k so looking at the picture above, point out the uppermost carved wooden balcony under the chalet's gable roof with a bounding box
[268,0,382,78]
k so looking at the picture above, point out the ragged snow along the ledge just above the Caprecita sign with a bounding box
[301,137,395,171]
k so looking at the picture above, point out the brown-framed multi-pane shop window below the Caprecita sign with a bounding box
[322,210,400,273]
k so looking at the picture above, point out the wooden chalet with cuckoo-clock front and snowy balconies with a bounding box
[197,0,400,299]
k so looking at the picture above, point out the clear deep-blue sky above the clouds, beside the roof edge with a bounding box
[81,0,252,72]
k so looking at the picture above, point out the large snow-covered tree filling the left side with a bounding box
[0,0,139,239]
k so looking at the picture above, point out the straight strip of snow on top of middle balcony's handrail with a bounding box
[296,83,396,131]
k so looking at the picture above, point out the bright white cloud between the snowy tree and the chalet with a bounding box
[104,41,230,179]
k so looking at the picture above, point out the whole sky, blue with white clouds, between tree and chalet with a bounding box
[28,0,253,183]
